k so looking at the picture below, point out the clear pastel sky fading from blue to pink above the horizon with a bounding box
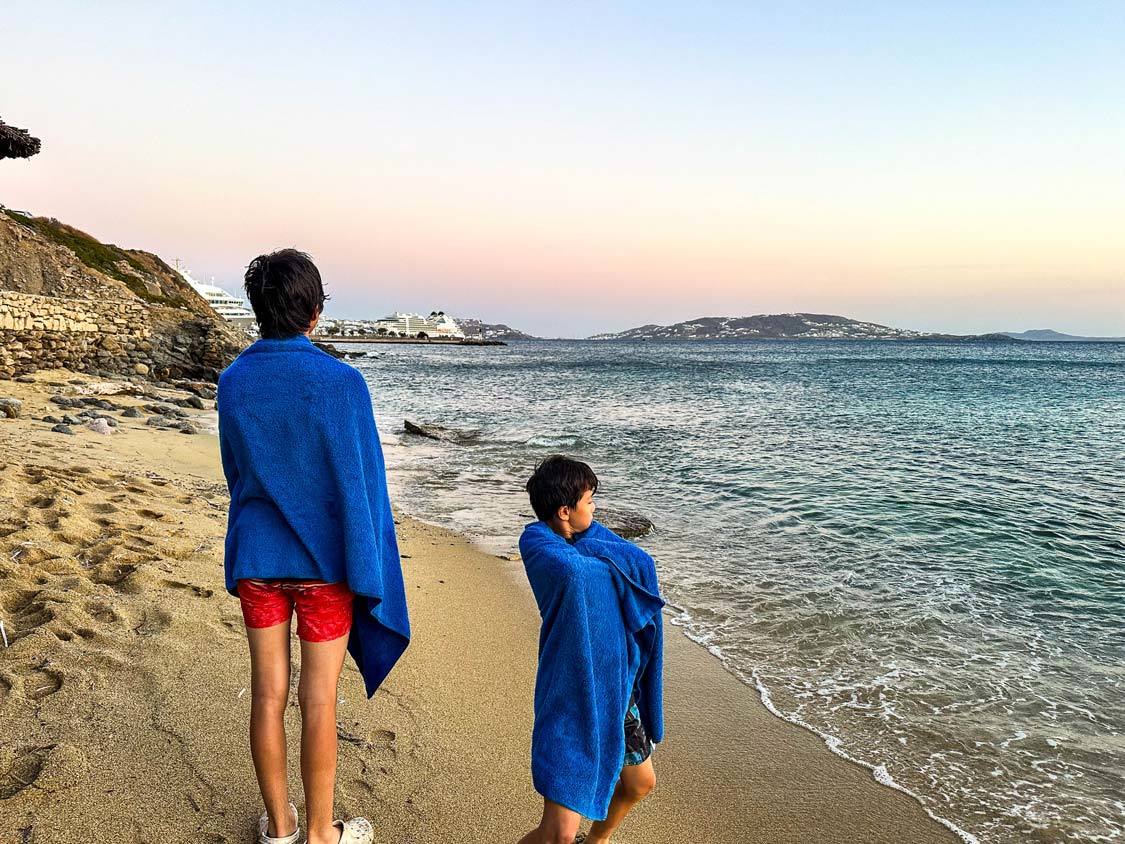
[0,0,1125,336]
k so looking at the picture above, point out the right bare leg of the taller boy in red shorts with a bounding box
[297,634,348,844]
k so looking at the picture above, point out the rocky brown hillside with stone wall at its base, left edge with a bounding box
[0,206,250,380]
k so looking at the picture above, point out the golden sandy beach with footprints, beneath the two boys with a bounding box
[0,370,955,844]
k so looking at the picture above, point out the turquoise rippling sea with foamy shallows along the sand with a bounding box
[349,341,1125,842]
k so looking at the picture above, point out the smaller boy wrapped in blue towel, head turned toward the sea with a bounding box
[520,456,664,844]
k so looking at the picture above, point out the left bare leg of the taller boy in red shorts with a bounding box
[246,621,295,837]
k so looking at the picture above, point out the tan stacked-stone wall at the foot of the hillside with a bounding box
[0,290,237,378]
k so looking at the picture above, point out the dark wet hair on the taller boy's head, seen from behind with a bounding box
[244,249,332,339]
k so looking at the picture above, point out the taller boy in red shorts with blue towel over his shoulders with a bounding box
[217,249,411,844]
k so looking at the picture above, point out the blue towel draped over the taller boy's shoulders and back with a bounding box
[217,334,411,697]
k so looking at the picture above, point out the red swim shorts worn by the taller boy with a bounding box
[239,580,354,641]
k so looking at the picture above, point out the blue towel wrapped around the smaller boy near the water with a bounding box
[520,521,664,820]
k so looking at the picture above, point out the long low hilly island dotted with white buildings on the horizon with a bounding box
[591,314,1016,343]
